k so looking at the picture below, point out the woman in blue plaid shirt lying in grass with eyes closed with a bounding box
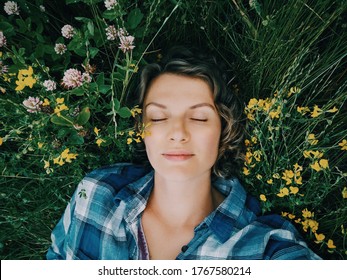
[47,46,319,259]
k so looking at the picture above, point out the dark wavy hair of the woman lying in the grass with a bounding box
[133,47,245,178]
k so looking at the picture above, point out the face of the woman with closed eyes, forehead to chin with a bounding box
[143,74,221,181]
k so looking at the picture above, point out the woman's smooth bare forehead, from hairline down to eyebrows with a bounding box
[144,73,214,104]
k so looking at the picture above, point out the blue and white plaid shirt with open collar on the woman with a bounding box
[47,164,319,260]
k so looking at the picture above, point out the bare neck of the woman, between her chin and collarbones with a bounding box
[147,174,222,226]
